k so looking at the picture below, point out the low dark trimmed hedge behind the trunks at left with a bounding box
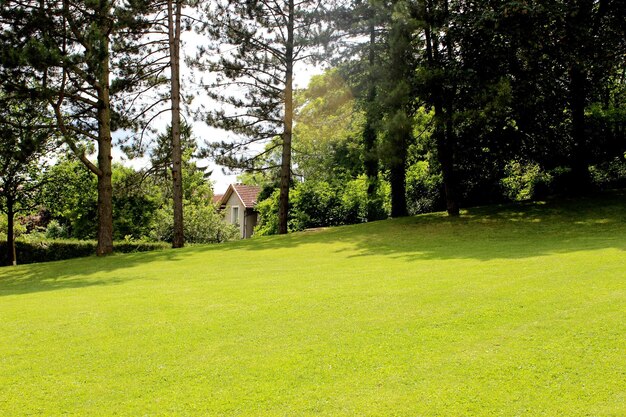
[0,240,169,265]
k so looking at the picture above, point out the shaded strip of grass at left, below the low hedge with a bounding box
[0,248,199,297]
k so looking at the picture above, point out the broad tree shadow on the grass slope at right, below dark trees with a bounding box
[220,190,626,261]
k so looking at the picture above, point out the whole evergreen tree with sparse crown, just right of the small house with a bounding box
[196,0,323,233]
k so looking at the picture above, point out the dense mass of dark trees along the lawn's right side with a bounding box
[330,0,626,216]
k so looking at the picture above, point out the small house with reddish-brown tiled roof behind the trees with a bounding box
[218,184,261,239]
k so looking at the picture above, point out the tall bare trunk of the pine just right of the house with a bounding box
[278,0,294,234]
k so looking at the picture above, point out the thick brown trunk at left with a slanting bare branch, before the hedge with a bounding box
[96,42,113,256]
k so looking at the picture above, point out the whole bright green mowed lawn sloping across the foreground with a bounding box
[0,192,626,416]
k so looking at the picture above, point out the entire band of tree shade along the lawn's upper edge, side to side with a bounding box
[0,191,626,297]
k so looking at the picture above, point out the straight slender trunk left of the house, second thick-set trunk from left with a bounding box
[167,0,185,248]
